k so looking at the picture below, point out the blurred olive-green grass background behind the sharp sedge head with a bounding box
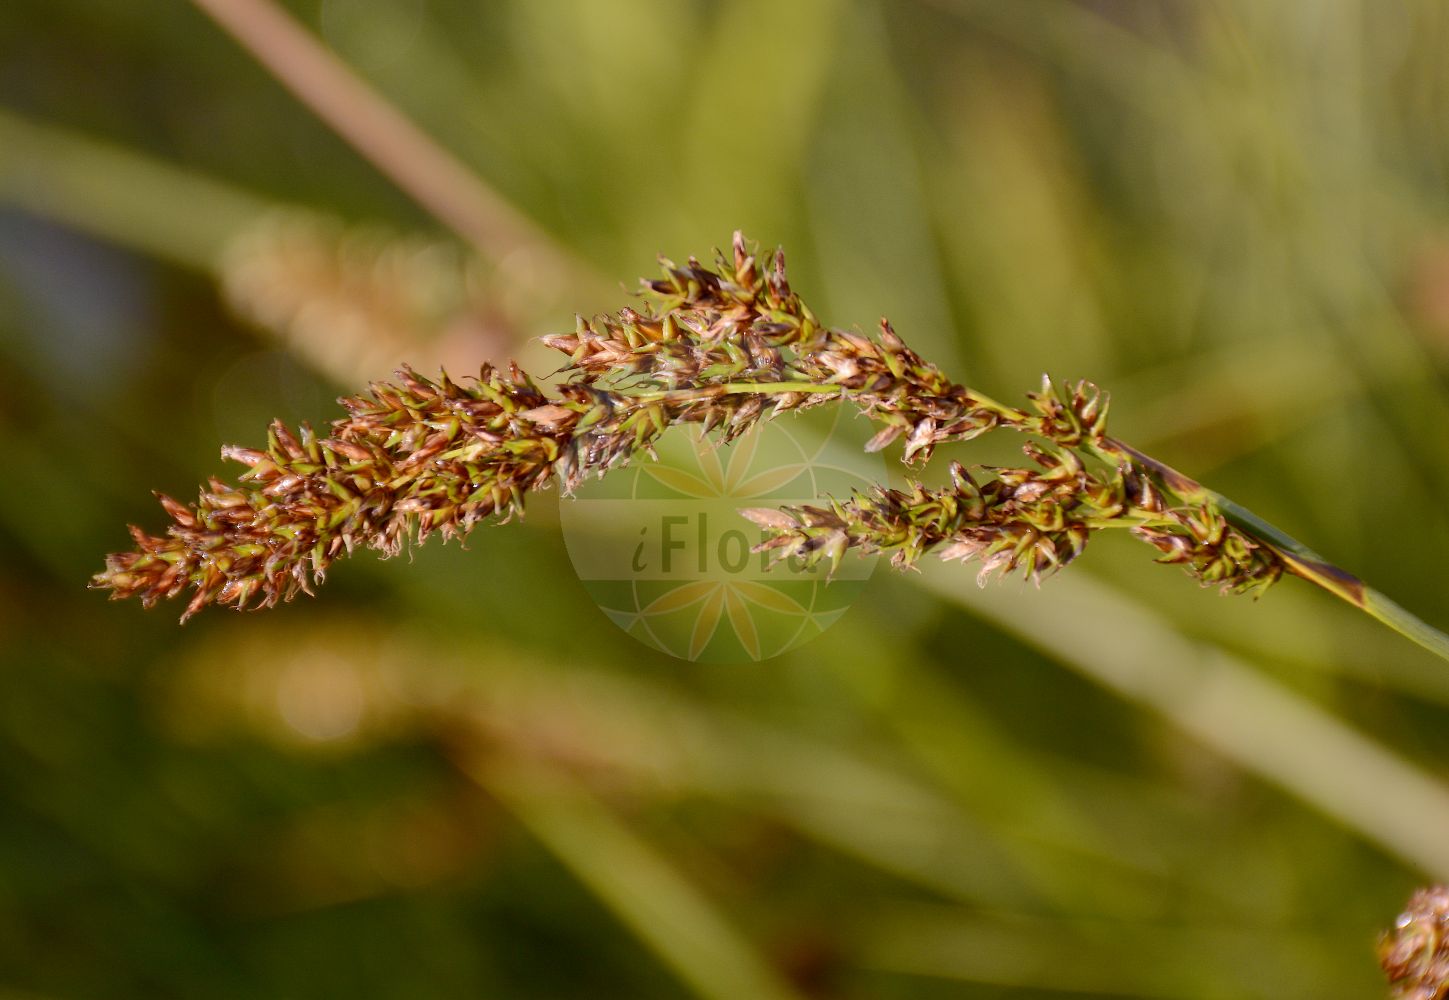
[0,0,1449,1000]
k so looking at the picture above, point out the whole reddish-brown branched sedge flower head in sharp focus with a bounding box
[93,233,1291,620]
